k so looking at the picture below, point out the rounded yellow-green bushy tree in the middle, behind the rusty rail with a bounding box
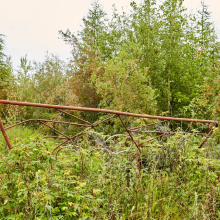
[92,45,157,114]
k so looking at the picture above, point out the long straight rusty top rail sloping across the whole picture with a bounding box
[0,100,218,125]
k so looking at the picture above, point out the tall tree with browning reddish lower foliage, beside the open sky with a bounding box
[60,1,107,107]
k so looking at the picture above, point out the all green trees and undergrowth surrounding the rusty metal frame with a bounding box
[0,0,220,219]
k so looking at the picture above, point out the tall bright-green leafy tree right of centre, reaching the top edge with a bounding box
[150,0,206,116]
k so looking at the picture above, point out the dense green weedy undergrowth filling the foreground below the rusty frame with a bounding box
[0,128,220,219]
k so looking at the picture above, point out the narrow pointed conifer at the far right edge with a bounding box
[188,1,220,119]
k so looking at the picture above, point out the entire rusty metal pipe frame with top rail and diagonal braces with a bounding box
[0,100,218,155]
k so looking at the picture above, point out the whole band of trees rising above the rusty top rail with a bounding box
[0,0,220,120]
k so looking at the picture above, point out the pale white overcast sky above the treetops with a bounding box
[0,0,220,69]
